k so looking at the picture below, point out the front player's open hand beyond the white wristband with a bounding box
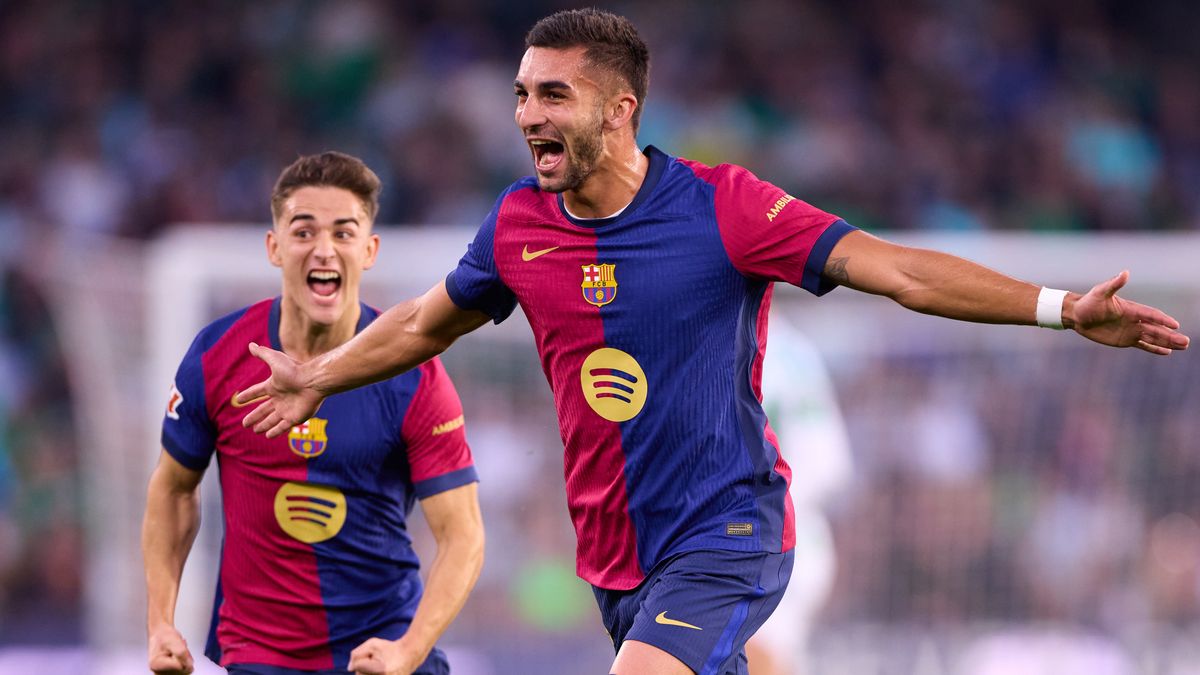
[1070,270,1190,356]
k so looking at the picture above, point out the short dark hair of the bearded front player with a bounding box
[526,7,650,133]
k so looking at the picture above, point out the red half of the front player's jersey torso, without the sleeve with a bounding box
[493,189,644,590]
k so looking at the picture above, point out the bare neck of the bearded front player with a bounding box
[563,138,650,217]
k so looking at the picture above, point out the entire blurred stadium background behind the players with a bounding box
[0,0,1200,675]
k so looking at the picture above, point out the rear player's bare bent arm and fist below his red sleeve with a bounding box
[349,483,484,675]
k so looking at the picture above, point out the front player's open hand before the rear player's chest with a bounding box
[236,342,325,438]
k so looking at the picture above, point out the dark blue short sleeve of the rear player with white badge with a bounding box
[162,338,216,471]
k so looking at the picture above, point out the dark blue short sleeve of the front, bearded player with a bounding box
[446,187,517,323]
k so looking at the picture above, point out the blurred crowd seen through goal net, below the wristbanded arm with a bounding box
[826,342,1200,629]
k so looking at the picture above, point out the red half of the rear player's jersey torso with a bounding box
[202,300,334,669]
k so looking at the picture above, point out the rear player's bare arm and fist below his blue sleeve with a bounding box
[142,450,204,675]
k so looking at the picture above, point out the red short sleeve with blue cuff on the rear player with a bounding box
[401,358,479,498]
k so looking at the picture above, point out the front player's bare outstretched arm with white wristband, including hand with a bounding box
[824,232,1189,356]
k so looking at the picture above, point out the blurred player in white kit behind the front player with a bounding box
[746,312,853,675]
